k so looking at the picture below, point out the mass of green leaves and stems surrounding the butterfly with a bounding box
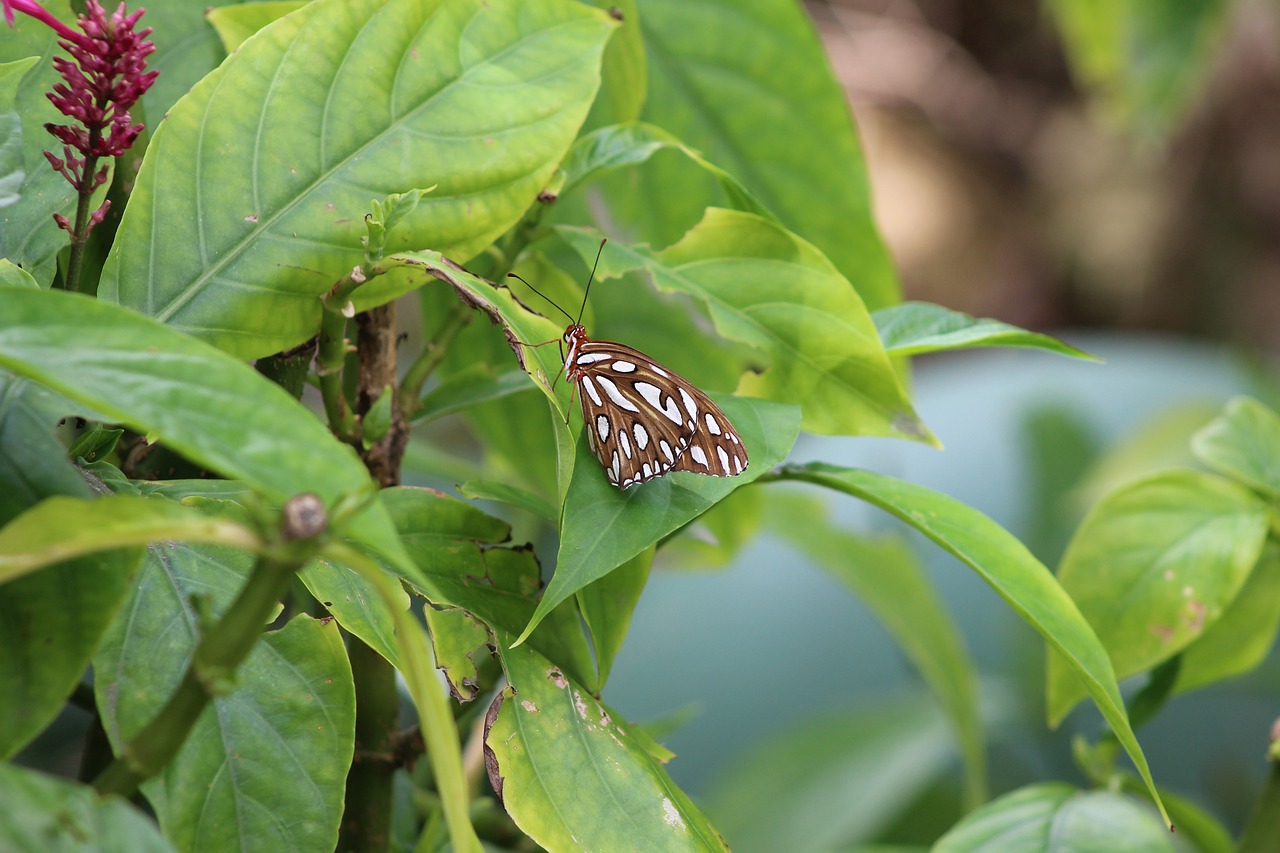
[0,0,1280,850]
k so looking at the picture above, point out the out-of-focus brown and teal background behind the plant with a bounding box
[605,0,1280,850]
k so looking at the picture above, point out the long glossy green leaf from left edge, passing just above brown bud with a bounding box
[0,288,413,573]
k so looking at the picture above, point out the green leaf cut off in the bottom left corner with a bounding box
[0,765,174,853]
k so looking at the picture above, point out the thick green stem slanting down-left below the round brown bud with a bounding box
[93,556,305,797]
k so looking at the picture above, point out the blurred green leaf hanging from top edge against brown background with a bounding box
[1047,0,1230,138]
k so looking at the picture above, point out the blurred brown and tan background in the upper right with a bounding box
[808,0,1280,356]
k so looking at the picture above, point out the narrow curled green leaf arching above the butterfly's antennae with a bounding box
[561,122,774,219]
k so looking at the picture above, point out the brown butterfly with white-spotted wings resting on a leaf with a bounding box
[508,240,748,489]
